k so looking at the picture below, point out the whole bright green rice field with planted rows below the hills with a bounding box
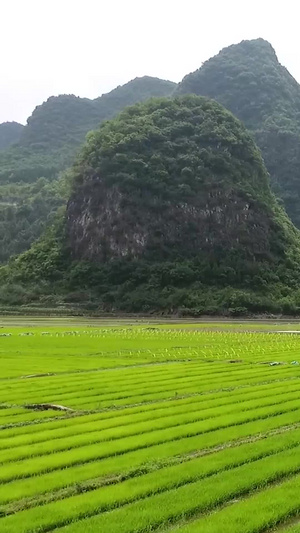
[0,318,300,533]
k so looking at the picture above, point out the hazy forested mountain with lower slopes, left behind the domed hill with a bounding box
[0,76,176,262]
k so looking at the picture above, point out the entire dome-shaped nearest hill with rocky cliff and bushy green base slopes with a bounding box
[4,96,300,315]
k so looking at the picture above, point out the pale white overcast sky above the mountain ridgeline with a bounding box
[0,0,300,124]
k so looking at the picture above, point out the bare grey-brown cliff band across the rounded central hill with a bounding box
[68,180,274,262]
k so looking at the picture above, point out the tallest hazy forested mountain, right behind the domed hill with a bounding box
[176,39,300,227]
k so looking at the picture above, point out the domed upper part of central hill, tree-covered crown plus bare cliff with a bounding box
[67,97,286,263]
